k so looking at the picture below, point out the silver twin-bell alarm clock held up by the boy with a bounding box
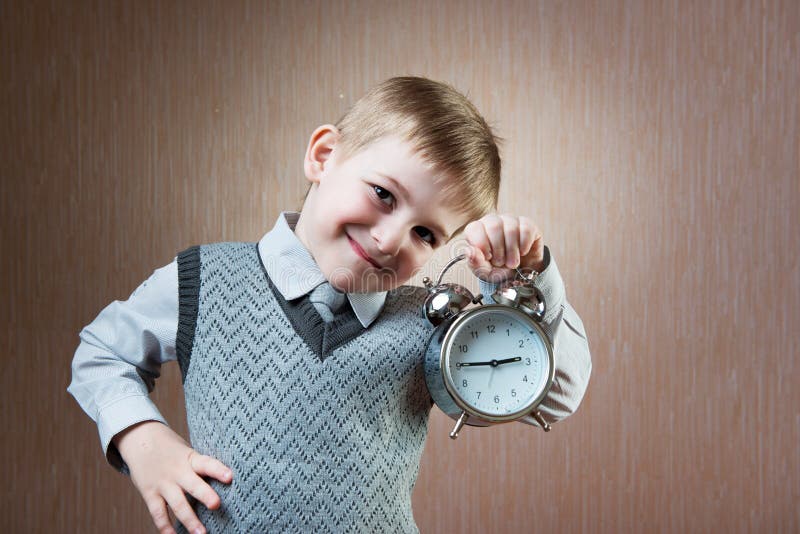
[423,254,555,439]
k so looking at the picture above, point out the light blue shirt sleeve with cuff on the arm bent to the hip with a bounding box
[67,259,178,471]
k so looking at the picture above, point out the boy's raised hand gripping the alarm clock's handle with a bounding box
[464,214,544,283]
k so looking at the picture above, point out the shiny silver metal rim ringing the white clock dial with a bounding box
[439,304,556,423]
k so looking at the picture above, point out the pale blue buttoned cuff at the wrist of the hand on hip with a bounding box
[97,395,167,475]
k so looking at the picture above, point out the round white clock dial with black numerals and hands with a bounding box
[442,306,552,418]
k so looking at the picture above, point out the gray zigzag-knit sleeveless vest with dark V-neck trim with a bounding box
[177,243,431,533]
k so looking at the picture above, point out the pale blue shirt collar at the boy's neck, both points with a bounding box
[258,211,386,328]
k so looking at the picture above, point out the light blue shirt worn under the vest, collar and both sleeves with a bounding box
[68,212,591,460]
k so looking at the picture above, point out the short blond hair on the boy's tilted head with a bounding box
[336,76,500,229]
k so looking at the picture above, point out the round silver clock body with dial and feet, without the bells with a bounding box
[424,304,555,437]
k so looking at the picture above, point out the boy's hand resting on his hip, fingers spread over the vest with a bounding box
[113,421,233,534]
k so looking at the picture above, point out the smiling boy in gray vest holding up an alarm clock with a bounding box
[69,77,591,532]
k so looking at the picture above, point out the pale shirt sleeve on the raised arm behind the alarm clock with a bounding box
[478,247,592,423]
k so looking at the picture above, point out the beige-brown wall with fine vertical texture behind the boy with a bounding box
[0,0,800,533]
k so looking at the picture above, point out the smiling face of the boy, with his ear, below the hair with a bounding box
[295,132,468,292]
